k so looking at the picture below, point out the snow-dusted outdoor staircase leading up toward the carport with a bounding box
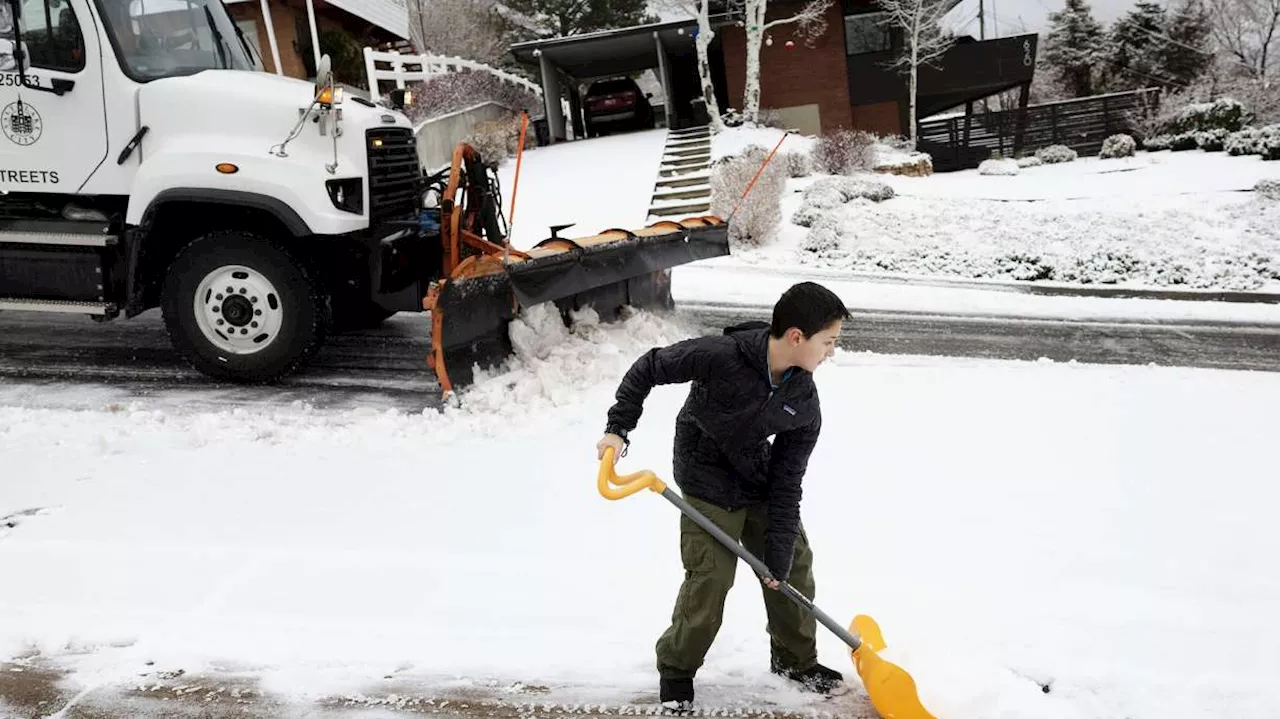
[648,127,712,223]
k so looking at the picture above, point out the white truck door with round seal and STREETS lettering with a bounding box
[0,0,108,193]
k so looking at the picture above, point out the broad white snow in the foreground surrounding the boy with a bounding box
[0,304,1280,719]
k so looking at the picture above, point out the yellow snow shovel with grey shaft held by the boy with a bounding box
[596,448,934,719]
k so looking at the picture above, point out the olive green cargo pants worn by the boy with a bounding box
[655,495,818,679]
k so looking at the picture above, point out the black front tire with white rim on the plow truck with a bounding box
[160,230,328,383]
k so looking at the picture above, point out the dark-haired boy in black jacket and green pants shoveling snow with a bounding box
[596,283,849,710]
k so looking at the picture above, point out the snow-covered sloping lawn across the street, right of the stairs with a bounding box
[736,145,1280,292]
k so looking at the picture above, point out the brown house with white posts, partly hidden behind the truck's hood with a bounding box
[225,0,408,87]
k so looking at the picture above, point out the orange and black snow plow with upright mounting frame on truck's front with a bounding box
[422,143,730,395]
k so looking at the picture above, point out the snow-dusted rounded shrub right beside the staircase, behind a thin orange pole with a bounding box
[710,145,787,247]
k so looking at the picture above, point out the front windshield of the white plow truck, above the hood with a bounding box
[99,0,262,82]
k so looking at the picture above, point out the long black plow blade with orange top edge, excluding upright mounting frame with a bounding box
[424,217,730,394]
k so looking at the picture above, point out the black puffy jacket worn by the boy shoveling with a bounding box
[605,322,822,580]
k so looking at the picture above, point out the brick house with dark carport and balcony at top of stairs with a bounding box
[511,0,1037,141]
